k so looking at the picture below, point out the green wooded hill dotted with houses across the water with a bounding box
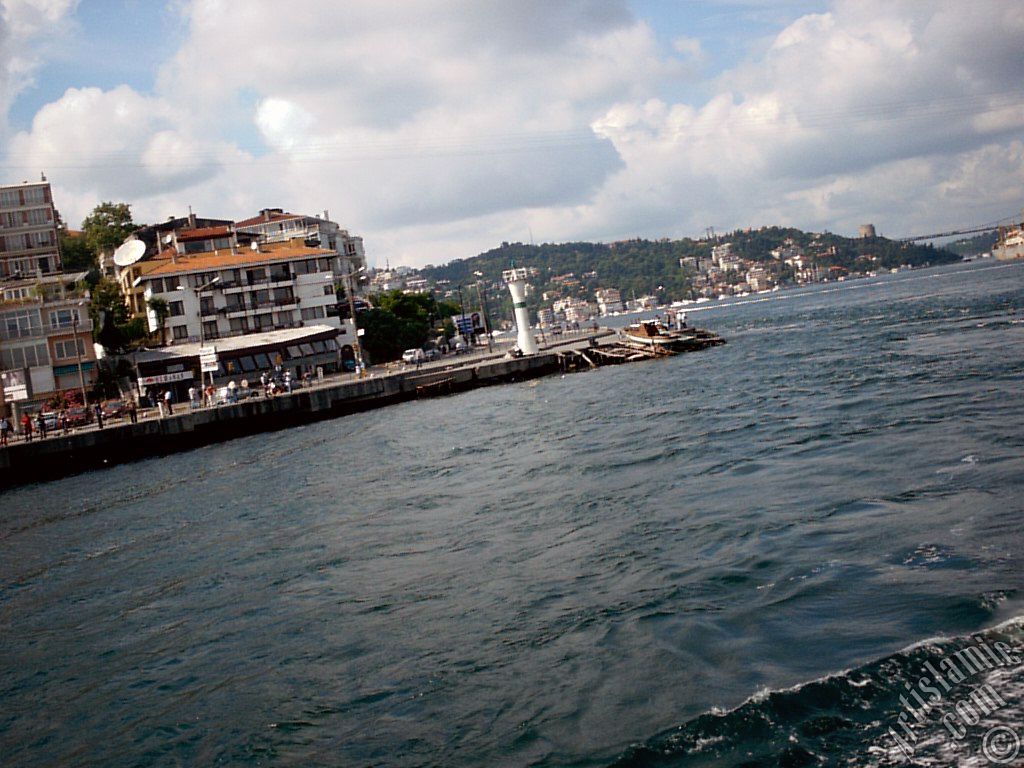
[421,226,961,316]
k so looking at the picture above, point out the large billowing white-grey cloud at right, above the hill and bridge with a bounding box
[564,0,1024,243]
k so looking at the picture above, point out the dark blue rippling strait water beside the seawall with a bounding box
[6,263,1024,767]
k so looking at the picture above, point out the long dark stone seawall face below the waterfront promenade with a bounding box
[0,352,560,488]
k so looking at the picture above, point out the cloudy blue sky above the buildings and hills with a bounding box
[0,0,1024,266]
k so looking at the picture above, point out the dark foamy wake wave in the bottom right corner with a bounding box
[613,615,1024,768]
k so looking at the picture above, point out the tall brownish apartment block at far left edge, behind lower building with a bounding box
[0,177,60,278]
